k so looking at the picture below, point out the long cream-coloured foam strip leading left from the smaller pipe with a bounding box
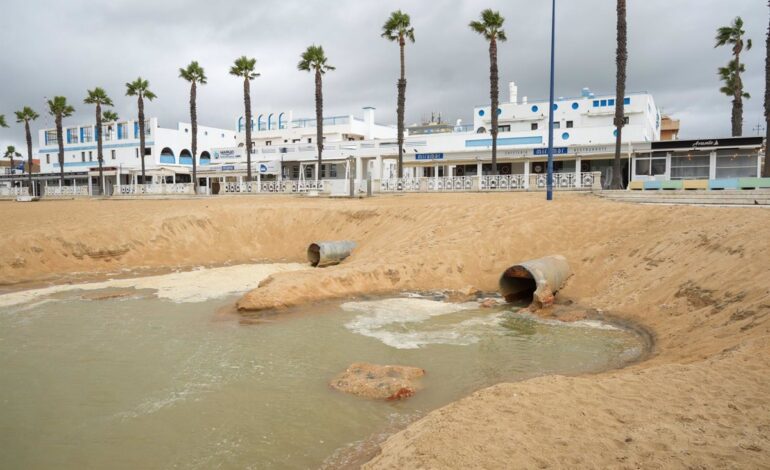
[0,263,307,307]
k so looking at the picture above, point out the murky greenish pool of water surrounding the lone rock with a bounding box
[0,266,642,469]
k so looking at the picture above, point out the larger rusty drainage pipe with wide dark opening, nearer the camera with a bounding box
[500,255,572,307]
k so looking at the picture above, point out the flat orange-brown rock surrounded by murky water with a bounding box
[330,362,425,400]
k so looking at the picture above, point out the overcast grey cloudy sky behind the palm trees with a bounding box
[0,0,768,148]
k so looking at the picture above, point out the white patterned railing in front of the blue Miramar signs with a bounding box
[380,171,601,192]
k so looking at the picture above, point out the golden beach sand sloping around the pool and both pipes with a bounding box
[0,193,770,468]
